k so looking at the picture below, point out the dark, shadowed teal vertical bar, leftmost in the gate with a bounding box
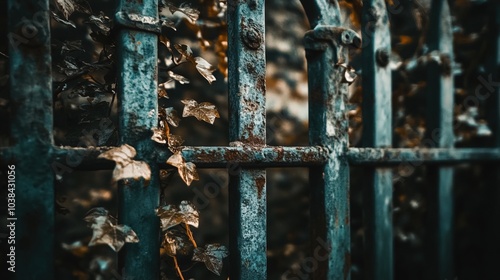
[4,0,54,279]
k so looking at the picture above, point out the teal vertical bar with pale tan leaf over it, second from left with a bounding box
[117,0,160,279]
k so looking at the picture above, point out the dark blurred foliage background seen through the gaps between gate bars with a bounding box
[0,0,498,279]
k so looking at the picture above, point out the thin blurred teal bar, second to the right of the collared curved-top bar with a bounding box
[424,0,454,279]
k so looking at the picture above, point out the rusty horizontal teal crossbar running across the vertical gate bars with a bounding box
[0,146,500,170]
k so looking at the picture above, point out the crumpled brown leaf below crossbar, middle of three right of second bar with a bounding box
[156,200,199,230]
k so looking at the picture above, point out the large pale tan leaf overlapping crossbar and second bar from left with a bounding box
[98,144,151,185]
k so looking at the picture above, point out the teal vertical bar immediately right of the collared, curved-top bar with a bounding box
[362,0,393,280]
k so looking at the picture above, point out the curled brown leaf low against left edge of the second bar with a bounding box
[84,207,139,252]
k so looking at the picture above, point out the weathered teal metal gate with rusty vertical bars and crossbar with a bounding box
[0,0,500,280]
